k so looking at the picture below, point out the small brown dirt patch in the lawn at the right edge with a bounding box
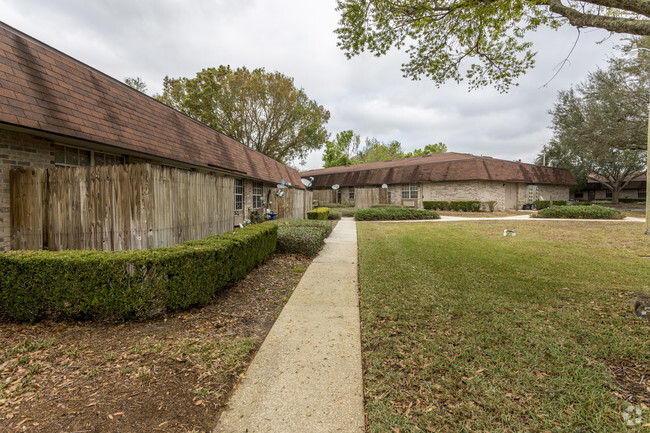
[605,359,650,405]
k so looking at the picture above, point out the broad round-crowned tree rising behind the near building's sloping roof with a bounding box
[156,66,330,163]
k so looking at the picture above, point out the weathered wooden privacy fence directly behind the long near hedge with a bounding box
[10,164,234,251]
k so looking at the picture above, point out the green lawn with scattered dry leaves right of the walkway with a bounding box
[357,221,650,433]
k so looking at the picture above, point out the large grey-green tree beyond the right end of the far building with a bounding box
[538,41,650,203]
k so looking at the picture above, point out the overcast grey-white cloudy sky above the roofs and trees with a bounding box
[0,0,620,169]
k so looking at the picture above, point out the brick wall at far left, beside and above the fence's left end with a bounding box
[0,130,54,251]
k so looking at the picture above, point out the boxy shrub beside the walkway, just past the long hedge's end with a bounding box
[277,219,332,255]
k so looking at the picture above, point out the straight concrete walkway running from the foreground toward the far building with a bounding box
[214,218,365,433]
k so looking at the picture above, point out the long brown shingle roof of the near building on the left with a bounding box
[0,22,303,188]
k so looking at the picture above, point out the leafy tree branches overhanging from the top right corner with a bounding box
[336,0,650,91]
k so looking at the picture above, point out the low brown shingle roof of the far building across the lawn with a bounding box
[301,152,577,189]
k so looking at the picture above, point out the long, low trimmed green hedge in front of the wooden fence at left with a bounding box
[0,223,277,322]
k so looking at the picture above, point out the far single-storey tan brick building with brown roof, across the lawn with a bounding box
[302,152,576,210]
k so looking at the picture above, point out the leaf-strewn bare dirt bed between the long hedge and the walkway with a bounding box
[0,254,310,433]
